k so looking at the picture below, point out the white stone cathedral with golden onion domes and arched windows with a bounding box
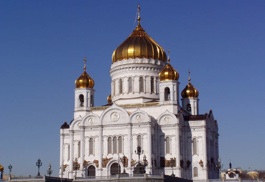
[59,6,219,181]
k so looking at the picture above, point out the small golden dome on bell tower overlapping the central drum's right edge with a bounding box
[159,63,179,81]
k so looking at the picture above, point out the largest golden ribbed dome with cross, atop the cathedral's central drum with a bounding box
[112,5,167,63]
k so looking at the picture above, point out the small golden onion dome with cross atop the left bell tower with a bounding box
[75,58,95,88]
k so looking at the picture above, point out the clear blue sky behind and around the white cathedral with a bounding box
[0,0,265,176]
